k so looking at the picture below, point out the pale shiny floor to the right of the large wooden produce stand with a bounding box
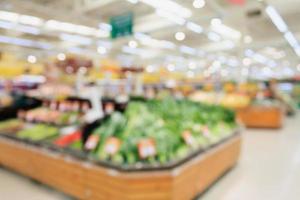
[201,113,300,200]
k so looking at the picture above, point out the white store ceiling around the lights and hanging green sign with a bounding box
[0,0,300,79]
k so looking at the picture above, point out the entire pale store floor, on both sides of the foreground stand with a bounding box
[0,114,300,200]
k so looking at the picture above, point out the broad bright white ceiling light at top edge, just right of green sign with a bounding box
[140,0,192,18]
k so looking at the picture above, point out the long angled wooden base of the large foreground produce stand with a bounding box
[0,134,241,200]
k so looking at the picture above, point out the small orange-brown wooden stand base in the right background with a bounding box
[237,105,285,128]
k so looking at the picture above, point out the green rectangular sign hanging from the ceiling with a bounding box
[110,12,133,39]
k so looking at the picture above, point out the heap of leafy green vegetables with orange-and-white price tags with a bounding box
[84,98,236,166]
